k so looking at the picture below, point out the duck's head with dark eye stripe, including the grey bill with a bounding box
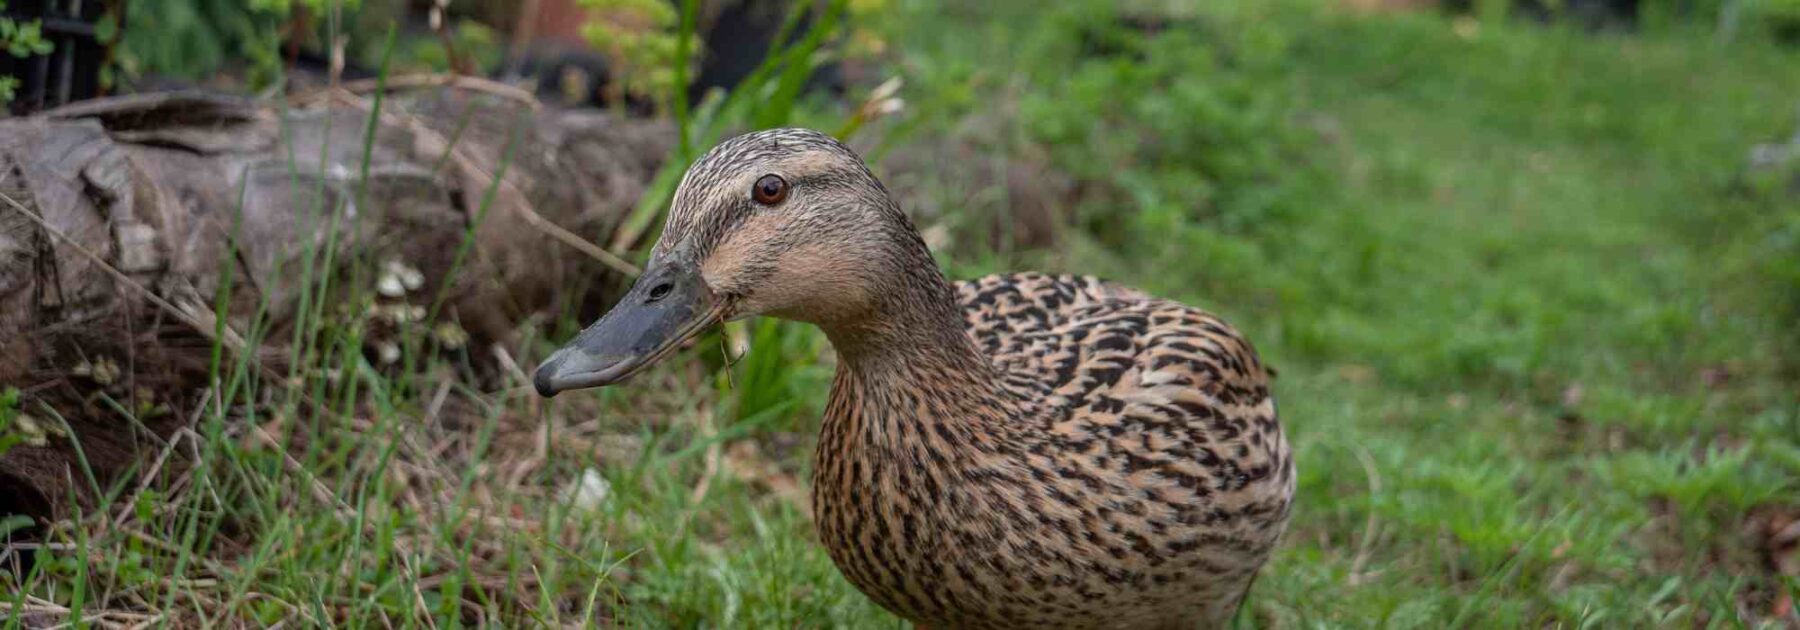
[533,130,936,396]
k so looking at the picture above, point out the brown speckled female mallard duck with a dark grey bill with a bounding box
[535,130,1294,628]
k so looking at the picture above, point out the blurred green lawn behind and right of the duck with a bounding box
[878,7,1800,626]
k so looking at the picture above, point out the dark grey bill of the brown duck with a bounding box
[531,256,724,398]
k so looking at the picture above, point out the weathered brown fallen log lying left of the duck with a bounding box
[0,90,673,517]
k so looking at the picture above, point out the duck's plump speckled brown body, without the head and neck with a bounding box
[814,274,1294,628]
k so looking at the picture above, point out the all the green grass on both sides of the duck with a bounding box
[0,2,1800,628]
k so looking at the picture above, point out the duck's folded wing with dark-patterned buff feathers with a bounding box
[959,274,1294,532]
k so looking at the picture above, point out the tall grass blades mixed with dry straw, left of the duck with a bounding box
[0,0,885,628]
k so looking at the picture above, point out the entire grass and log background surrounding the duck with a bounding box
[0,0,1800,628]
